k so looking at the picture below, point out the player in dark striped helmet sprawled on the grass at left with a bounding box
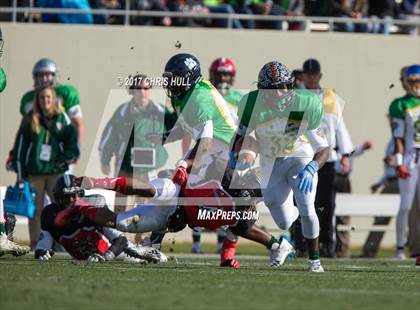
[35,175,166,263]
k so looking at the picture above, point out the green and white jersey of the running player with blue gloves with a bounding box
[238,90,328,158]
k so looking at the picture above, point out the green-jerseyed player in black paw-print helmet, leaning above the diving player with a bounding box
[163,54,237,184]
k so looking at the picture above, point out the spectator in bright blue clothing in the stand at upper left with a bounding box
[36,0,93,24]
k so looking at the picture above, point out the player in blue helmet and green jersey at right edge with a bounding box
[389,65,420,259]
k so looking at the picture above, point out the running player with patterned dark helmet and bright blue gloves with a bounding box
[231,61,328,272]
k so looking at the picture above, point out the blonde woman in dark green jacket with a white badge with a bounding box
[13,86,80,248]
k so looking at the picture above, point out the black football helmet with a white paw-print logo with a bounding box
[163,53,201,98]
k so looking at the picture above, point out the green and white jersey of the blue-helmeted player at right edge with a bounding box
[389,94,420,150]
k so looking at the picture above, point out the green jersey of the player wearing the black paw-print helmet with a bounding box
[172,80,237,144]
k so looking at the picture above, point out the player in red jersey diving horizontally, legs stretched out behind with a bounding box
[72,171,294,268]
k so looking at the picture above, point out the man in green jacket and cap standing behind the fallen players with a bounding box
[99,74,177,242]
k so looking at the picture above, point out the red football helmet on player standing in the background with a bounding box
[210,57,236,90]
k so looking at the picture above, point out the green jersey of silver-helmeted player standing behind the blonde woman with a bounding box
[20,84,82,118]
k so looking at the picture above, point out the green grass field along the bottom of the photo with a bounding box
[0,248,420,310]
